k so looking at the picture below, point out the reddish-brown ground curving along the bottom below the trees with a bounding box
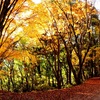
[0,77,100,100]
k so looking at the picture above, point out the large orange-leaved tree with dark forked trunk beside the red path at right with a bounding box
[41,1,96,84]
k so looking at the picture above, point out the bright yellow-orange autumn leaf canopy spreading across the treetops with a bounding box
[0,0,96,68]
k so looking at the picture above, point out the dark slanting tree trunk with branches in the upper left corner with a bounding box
[0,0,18,38]
